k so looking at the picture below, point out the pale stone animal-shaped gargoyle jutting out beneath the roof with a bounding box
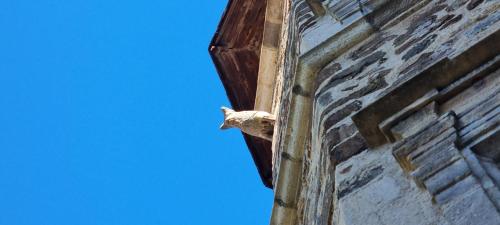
[220,107,276,141]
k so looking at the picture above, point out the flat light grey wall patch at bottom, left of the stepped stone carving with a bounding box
[331,149,449,225]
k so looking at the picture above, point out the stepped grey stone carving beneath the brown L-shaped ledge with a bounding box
[394,109,484,203]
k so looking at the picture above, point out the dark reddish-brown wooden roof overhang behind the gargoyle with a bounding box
[209,0,272,188]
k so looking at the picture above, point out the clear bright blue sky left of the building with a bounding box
[0,0,273,225]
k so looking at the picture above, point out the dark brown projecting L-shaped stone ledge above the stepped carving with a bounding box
[353,28,500,147]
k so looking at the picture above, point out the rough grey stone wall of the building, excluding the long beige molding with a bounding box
[274,0,500,225]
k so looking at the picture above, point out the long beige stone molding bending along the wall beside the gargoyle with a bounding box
[271,0,426,225]
